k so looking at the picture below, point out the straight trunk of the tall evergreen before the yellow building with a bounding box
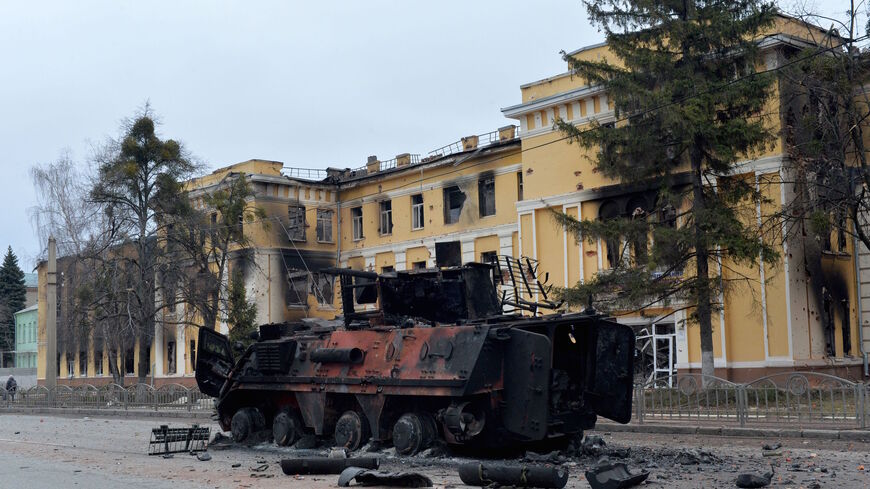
[691,143,714,385]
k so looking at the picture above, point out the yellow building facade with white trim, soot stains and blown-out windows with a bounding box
[39,14,870,385]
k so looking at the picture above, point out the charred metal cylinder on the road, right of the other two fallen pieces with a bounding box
[459,462,568,489]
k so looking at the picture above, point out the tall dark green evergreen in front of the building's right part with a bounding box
[557,0,776,375]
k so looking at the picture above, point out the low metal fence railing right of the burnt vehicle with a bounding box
[634,372,870,428]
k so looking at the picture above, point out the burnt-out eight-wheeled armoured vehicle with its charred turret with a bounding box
[196,257,635,454]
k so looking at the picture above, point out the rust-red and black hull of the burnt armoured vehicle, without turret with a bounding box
[197,314,634,453]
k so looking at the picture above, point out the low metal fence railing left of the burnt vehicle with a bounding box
[0,384,214,411]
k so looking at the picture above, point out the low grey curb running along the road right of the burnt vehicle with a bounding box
[594,423,870,441]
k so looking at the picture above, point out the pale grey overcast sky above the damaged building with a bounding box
[0,0,860,271]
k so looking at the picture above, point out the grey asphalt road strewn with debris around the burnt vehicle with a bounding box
[0,414,870,489]
